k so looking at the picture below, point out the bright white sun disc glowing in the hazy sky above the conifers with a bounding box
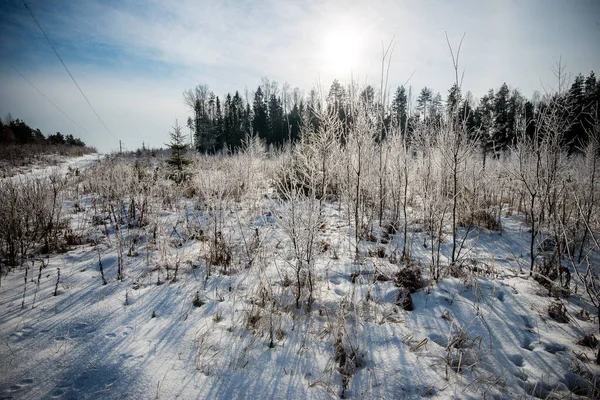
[322,22,362,74]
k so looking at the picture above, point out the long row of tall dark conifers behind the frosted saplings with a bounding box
[184,71,600,155]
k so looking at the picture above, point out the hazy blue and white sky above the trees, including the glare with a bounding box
[0,0,600,152]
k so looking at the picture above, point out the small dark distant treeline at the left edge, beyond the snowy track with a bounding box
[0,114,85,147]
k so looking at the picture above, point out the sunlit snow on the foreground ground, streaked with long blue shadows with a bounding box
[0,155,600,399]
